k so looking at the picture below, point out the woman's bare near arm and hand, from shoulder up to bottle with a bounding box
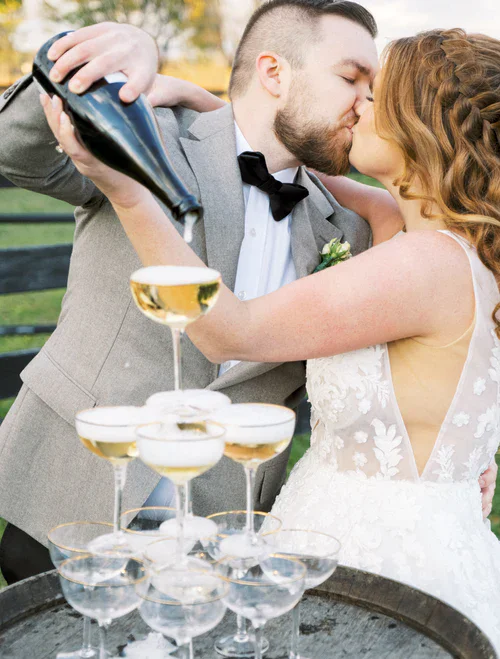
[43,98,472,362]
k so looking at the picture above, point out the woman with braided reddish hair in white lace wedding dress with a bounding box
[43,30,500,650]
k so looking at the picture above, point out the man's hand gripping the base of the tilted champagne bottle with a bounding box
[48,22,159,103]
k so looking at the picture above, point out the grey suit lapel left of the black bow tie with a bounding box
[181,105,245,290]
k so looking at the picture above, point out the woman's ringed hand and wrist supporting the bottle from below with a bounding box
[40,94,146,208]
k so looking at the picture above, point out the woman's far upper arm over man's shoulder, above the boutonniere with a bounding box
[315,172,403,245]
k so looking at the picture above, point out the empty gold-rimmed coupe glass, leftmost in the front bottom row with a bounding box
[57,554,149,659]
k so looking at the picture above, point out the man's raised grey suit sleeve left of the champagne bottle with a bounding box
[0,75,102,206]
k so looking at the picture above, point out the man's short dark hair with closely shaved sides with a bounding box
[229,0,377,99]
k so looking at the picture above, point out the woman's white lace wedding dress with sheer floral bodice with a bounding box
[272,232,500,654]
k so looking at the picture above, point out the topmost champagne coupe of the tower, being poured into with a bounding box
[130,265,222,389]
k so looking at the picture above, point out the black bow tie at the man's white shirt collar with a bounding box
[238,151,309,222]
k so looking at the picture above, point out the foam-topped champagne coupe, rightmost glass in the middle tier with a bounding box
[210,403,295,558]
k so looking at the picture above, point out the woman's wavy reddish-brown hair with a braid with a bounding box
[376,29,500,338]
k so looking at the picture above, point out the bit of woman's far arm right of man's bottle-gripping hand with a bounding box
[147,73,225,112]
